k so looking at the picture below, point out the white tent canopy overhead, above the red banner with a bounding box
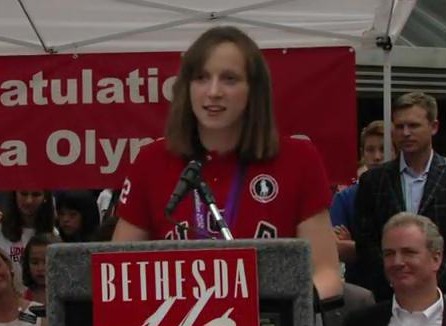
[0,0,416,55]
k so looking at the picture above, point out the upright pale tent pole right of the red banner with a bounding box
[383,50,392,162]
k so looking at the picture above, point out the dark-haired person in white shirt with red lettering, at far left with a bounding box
[0,190,55,293]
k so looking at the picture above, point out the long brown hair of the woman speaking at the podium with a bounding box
[166,26,279,162]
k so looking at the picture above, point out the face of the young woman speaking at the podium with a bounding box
[190,42,249,133]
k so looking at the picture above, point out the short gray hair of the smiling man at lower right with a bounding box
[383,212,444,253]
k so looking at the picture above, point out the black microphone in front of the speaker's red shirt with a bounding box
[164,160,201,216]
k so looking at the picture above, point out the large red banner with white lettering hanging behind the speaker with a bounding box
[0,48,356,190]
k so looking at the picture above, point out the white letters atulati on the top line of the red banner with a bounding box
[0,67,176,107]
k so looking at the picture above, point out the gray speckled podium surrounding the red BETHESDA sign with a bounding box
[47,239,314,326]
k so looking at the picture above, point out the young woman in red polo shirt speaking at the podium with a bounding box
[113,26,342,299]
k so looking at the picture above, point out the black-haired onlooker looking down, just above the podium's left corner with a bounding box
[56,190,99,242]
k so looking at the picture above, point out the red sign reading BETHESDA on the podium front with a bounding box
[92,249,259,326]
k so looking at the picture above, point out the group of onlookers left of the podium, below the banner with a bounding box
[0,190,106,326]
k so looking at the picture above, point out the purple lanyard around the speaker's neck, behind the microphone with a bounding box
[193,164,246,237]
